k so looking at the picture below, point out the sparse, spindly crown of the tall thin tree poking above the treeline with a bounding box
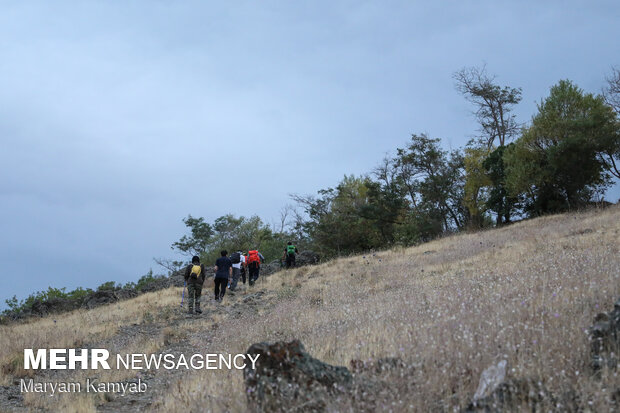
[453,66,521,149]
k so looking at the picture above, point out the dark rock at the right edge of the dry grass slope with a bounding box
[589,299,620,372]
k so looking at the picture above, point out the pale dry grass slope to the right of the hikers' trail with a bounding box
[156,208,620,411]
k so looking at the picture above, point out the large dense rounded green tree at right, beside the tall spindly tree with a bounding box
[504,80,617,214]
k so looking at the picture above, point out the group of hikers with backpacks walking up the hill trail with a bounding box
[181,241,298,314]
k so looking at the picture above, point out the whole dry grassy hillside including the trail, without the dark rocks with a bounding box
[0,206,620,412]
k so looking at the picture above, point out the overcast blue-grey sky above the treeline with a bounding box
[0,0,620,308]
